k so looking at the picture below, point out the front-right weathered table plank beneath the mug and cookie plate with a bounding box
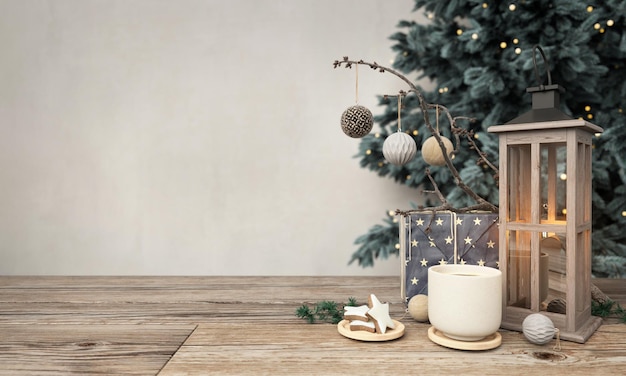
[159,320,626,376]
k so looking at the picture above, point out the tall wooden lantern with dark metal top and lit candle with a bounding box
[489,47,602,343]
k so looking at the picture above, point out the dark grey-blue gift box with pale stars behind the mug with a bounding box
[401,211,499,302]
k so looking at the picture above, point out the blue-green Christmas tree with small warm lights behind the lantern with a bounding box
[350,0,626,278]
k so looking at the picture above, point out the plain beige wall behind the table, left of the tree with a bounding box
[0,0,418,275]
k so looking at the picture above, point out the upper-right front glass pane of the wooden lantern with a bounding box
[540,143,567,223]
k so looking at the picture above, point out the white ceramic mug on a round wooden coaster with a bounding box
[428,264,502,341]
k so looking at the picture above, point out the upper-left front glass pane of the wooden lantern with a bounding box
[507,144,532,223]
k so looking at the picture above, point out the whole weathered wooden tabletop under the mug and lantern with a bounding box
[0,276,626,376]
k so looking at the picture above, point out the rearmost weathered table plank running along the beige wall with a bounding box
[0,277,400,303]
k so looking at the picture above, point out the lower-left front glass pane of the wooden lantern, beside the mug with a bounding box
[506,231,531,308]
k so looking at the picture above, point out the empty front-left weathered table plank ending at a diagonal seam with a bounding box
[0,324,195,375]
